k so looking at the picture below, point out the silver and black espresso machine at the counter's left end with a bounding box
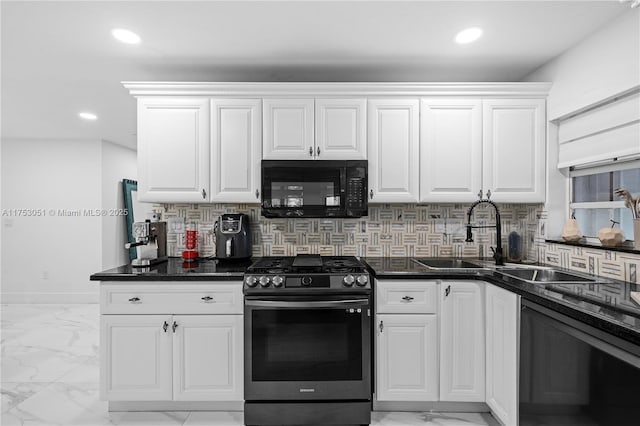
[124,220,167,267]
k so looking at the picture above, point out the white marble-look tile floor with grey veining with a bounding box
[0,304,497,426]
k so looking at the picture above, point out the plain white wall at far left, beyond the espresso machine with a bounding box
[1,140,135,303]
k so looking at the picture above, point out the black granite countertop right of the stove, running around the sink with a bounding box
[362,257,640,345]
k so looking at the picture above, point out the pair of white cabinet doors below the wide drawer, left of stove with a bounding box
[101,315,243,401]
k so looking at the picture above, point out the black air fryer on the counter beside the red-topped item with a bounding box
[214,213,251,259]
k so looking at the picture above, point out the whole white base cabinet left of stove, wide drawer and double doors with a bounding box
[100,282,244,401]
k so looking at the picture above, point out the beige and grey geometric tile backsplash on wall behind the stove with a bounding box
[159,204,546,261]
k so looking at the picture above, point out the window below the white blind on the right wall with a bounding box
[569,160,640,242]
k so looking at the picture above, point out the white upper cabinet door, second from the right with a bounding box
[420,98,482,202]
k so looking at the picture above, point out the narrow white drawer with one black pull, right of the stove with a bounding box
[376,280,438,314]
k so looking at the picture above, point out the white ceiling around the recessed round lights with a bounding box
[0,0,629,148]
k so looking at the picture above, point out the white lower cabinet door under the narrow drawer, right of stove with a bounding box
[376,314,438,401]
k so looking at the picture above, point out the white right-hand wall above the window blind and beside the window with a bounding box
[523,8,640,238]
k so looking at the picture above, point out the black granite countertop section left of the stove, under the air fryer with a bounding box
[89,257,252,281]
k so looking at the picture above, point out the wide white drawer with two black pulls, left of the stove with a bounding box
[100,281,243,314]
